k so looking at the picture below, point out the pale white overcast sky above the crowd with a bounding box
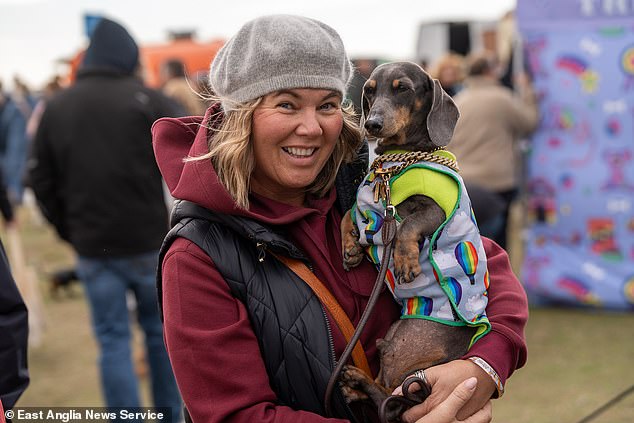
[0,0,516,90]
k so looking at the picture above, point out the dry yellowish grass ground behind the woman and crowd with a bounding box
[6,204,634,423]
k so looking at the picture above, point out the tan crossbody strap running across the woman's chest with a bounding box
[274,254,372,377]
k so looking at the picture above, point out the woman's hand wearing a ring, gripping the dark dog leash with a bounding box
[394,360,496,423]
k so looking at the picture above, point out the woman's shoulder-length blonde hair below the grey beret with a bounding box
[186,97,361,210]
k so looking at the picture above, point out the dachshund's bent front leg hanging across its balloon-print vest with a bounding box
[394,195,445,283]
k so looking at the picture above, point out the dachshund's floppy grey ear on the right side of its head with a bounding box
[427,79,460,147]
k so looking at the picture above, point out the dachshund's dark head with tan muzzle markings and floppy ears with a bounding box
[361,62,459,154]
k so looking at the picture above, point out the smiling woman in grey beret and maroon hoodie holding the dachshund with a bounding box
[153,15,527,423]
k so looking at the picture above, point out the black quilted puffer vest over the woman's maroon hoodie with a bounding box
[157,201,353,420]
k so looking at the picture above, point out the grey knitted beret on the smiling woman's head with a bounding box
[209,15,352,110]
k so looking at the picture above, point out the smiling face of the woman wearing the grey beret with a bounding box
[251,88,343,205]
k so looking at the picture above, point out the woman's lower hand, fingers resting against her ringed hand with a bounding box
[416,377,492,423]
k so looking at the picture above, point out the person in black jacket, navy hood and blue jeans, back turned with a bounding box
[29,18,184,421]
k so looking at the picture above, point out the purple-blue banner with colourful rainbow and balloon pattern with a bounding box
[516,0,634,310]
